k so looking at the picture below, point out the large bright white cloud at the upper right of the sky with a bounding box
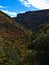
[19,0,49,9]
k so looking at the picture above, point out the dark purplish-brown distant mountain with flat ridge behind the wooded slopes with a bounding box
[14,9,49,31]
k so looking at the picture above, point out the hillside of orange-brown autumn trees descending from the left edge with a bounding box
[0,11,31,65]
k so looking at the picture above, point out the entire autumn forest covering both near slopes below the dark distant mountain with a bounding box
[0,11,49,65]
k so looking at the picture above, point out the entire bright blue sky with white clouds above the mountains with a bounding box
[0,0,49,17]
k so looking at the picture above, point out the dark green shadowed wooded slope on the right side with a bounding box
[28,23,49,65]
